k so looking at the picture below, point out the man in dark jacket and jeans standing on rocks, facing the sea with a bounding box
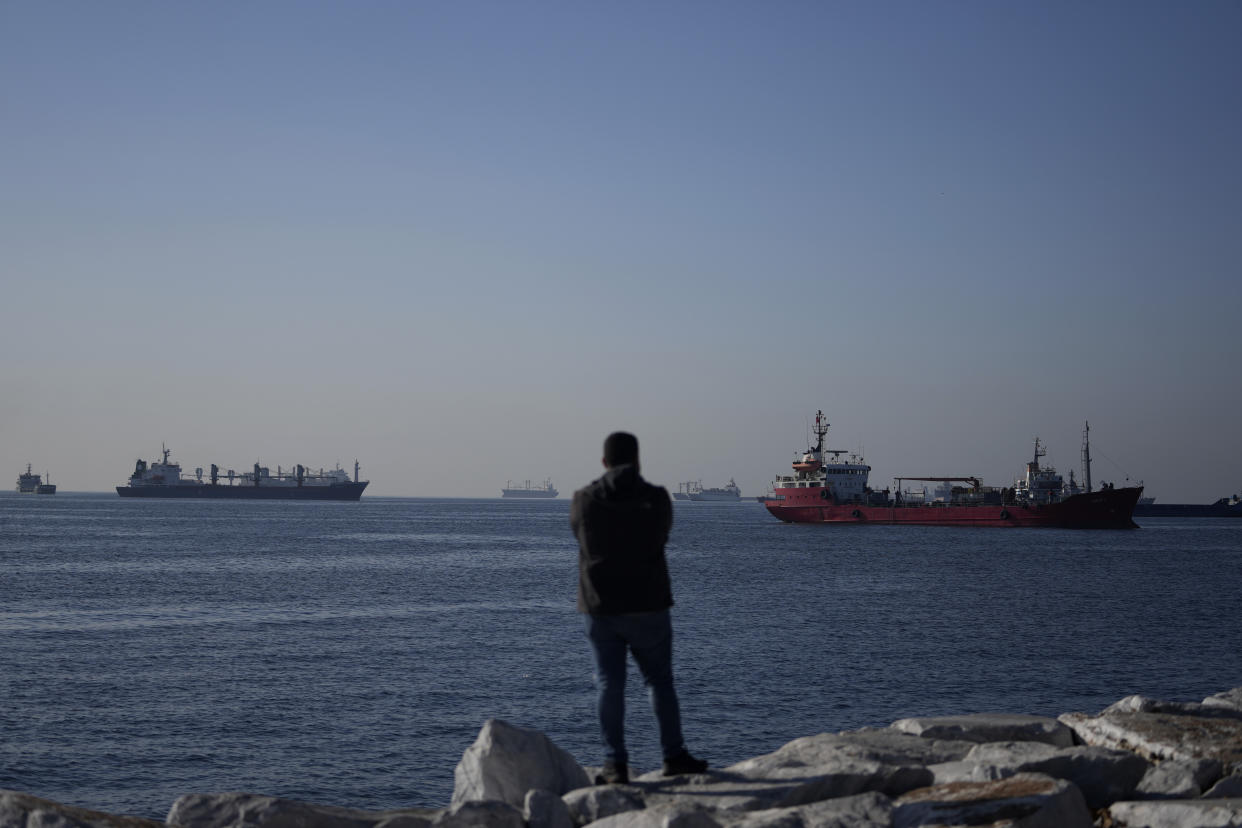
[569,431,707,785]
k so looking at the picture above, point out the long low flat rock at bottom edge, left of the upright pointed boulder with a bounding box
[166,793,438,828]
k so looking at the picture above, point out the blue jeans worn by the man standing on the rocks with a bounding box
[586,610,686,763]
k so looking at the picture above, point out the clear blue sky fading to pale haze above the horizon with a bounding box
[0,0,1242,502]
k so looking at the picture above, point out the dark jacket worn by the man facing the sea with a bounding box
[569,466,673,616]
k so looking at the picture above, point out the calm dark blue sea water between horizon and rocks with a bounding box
[0,493,1242,819]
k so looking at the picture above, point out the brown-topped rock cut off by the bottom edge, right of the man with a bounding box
[893,773,1092,828]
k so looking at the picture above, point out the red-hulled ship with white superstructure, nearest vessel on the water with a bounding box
[764,411,1143,529]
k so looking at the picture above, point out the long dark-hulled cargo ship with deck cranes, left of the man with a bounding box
[117,448,369,500]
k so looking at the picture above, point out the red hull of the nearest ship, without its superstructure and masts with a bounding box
[764,487,1143,529]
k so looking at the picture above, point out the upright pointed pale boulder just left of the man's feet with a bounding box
[451,719,591,808]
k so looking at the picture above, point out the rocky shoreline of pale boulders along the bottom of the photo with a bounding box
[0,686,1242,828]
